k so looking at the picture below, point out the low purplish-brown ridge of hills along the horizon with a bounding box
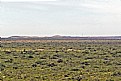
[0,35,121,40]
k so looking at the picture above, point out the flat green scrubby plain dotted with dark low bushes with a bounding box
[0,40,121,81]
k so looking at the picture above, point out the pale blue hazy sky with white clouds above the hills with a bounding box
[0,0,121,37]
